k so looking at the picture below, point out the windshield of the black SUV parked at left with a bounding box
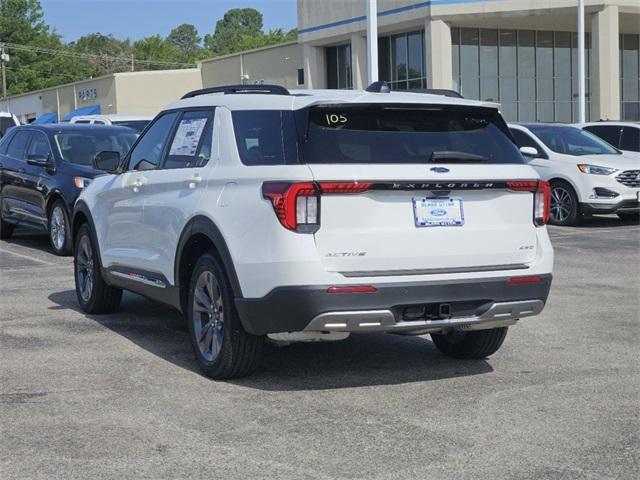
[53,128,138,166]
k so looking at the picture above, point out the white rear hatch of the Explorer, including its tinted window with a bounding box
[302,105,537,277]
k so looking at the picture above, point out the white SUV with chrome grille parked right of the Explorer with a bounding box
[509,123,640,225]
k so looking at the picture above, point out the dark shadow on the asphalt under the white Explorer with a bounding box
[49,290,493,391]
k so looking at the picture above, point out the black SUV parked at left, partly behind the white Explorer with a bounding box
[0,124,137,255]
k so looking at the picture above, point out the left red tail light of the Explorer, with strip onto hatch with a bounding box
[262,182,373,233]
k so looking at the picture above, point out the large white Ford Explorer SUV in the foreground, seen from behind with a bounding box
[73,84,553,378]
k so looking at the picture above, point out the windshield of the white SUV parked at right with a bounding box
[527,125,620,156]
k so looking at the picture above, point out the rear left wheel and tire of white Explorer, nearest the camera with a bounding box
[186,253,264,379]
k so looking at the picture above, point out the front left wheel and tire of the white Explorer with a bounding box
[73,223,122,314]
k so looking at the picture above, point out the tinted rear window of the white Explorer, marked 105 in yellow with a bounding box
[302,105,524,164]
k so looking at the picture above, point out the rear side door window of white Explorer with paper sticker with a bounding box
[163,110,213,168]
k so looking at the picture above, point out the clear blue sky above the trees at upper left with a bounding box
[40,0,297,42]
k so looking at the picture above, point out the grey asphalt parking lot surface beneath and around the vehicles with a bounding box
[0,217,640,480]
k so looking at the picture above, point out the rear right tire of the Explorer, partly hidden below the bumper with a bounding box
[431,327,508,360]
